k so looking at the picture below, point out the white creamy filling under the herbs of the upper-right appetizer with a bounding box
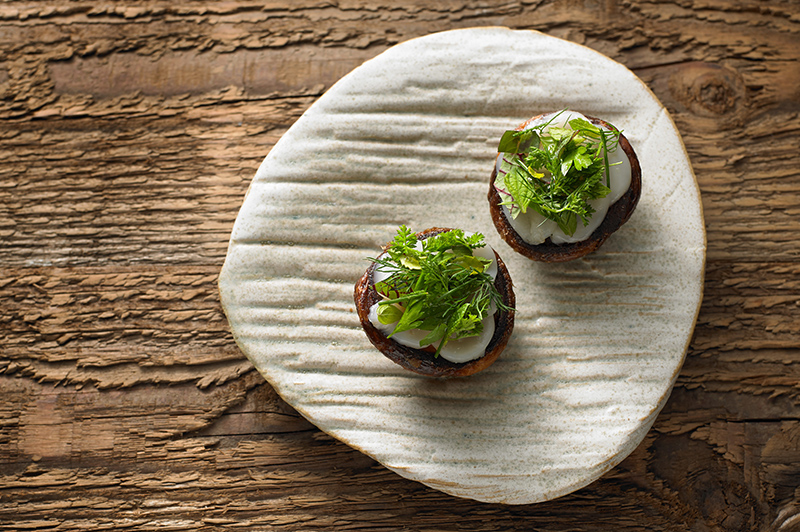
[496,111,631,244]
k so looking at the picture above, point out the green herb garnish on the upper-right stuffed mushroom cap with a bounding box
[495,113,619,236]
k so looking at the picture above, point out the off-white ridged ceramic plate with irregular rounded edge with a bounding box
[219,28,705,504]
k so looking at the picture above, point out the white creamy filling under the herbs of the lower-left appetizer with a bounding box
[369,241,497,364]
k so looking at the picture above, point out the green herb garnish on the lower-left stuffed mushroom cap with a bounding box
[369,226,511,356]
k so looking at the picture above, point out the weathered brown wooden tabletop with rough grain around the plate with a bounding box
[0,0,800,532]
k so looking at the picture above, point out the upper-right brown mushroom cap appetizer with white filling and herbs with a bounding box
[489,111,641,262]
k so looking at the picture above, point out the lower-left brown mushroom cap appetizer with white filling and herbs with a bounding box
[354,226,515,377]
